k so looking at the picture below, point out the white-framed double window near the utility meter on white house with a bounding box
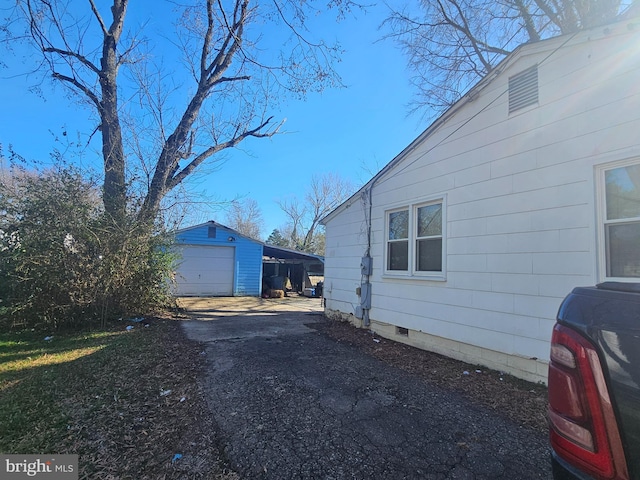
[385,199,444,278]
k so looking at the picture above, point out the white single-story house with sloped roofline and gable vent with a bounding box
[323,18,640,382]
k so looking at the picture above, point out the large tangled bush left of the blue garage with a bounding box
[0,168,173,328]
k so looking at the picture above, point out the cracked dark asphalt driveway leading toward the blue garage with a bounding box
[182,298,551,480]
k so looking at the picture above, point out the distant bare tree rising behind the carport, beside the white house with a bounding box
[278,173,355,254]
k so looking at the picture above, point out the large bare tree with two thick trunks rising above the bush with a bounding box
[0,0,349,228]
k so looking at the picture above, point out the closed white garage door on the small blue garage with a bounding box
[176,245,235,297]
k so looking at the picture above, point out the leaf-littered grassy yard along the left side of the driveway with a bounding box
[0,319,236,479]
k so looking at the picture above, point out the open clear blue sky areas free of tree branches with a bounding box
[0,1,426,237]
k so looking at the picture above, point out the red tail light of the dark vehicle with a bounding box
[548,324,629,480]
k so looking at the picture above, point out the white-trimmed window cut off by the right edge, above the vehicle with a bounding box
[602,163,640,279]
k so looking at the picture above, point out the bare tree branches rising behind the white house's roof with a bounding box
[385,0,634,113]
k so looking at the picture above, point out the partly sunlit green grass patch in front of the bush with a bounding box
[0,331,127,453]
